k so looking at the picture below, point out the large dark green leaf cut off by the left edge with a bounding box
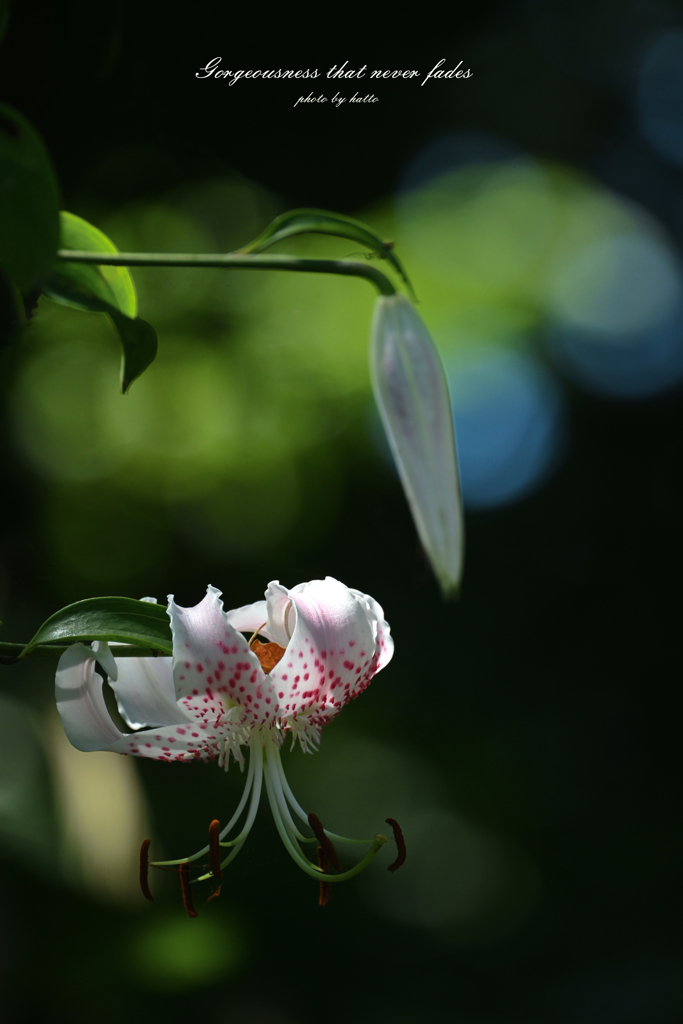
[0,103,59,293]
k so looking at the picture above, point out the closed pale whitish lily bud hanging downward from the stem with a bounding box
[370,295,464,594]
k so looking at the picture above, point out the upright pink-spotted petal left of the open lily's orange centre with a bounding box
[168,587,278,727]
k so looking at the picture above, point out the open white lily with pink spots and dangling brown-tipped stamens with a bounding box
[55,577,404,915]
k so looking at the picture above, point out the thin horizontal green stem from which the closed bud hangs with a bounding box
[57,249,396,295]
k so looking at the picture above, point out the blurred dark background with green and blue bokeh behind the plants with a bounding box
[0,0,683,1024]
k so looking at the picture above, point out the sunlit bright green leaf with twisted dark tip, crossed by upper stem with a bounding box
[43,210,157,394]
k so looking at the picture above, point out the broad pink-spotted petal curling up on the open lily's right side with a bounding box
[270,577,388,724]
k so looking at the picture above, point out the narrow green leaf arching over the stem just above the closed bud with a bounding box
[239,210,415,297]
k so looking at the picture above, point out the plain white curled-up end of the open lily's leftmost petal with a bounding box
[54,643,123,751]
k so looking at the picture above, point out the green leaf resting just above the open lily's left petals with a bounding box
[19,597,173,657]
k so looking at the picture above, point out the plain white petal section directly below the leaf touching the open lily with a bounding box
[110,657,191,729]
